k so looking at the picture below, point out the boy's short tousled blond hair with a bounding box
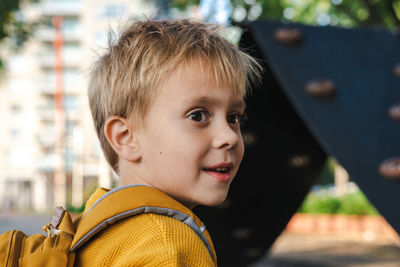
[88,20,260,172]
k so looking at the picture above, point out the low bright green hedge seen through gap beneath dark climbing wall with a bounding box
[298,187,379,215]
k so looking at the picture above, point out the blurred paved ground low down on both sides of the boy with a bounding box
[0,214,400,267]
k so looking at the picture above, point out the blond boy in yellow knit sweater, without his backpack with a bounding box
[76,20,259,266]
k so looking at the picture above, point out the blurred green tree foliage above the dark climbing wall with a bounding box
[171,0,400,29]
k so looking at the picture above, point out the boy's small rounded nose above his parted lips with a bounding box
[213,122,240,149]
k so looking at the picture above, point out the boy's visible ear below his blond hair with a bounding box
[104,116,141,162]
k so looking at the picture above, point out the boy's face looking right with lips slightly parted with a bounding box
[133,65,245,208]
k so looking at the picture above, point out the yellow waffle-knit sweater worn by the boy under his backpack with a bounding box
[74,188,217,267]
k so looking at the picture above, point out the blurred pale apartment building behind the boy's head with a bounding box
[0,0,156,214]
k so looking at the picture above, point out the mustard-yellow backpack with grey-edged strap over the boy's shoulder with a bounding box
[0,185,215,267]
